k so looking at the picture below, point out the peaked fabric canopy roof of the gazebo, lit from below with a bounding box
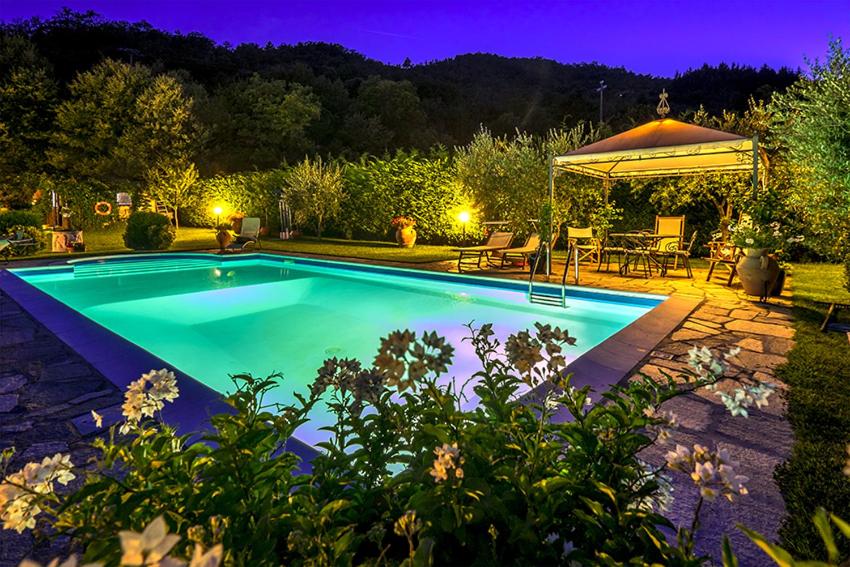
[553,118,757,179]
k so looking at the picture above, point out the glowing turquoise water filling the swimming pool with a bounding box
[14,255,660,444]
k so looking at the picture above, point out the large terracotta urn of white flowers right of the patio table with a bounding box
[729,216,803,300]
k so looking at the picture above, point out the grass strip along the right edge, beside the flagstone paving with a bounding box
[776,264,850,559]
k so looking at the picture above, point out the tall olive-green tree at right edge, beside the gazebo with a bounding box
[770,40,850,289]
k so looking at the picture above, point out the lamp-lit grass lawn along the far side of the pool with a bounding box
[6,227,457,264]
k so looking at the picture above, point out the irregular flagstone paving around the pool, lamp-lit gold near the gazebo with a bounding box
[0,254,793,567]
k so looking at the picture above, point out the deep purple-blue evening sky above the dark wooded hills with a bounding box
[0,0,850,76]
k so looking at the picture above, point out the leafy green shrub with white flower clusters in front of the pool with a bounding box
[0,324,780,565]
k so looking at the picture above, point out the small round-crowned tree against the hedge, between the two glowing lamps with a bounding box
[287,157,345,238]
